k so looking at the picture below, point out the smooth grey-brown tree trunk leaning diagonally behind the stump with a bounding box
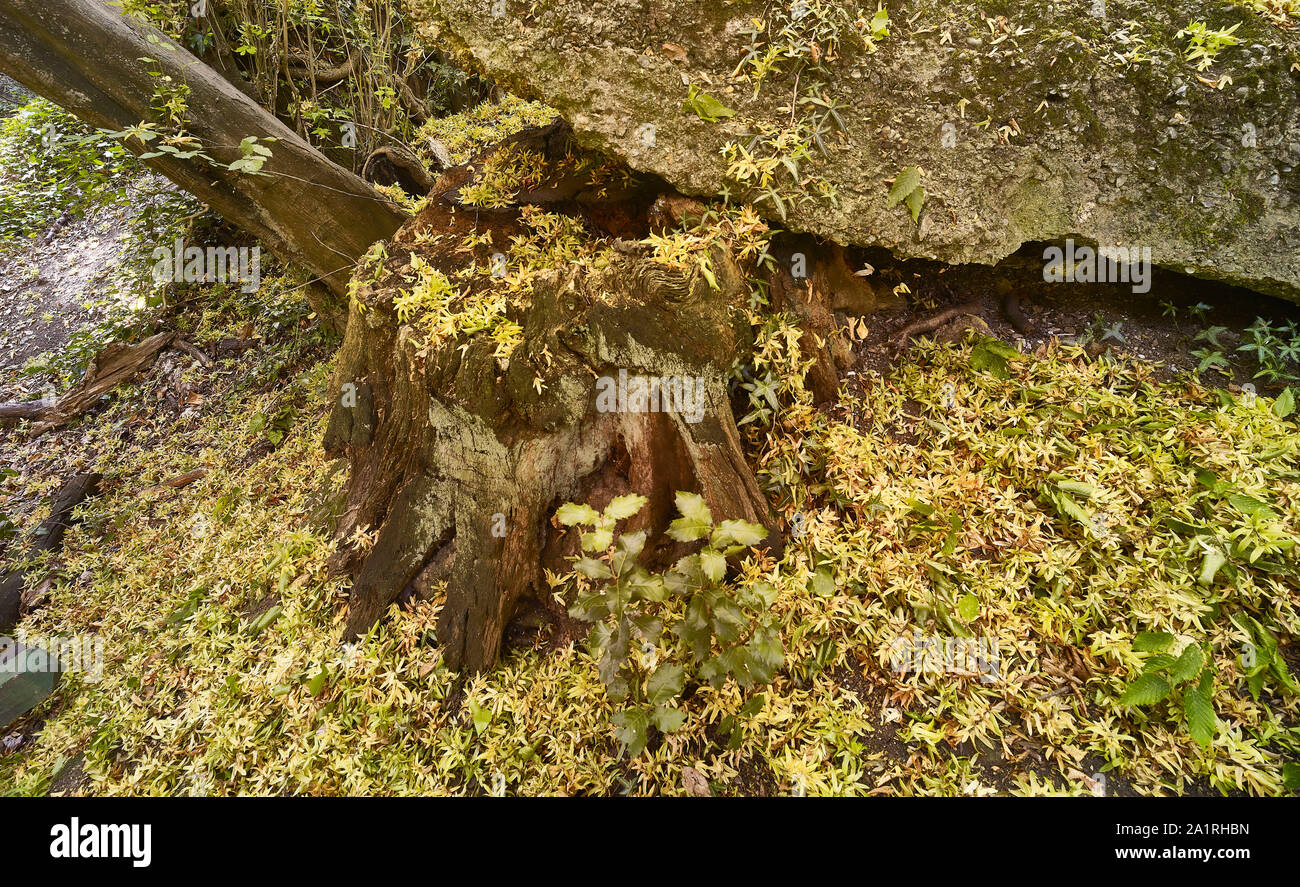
[0,0,404,321]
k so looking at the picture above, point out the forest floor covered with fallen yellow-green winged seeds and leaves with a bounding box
[0,94,1300,795]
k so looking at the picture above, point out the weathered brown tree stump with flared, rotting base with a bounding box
[325,136,777,671]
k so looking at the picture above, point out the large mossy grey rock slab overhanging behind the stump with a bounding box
[412,0,1300,300]
